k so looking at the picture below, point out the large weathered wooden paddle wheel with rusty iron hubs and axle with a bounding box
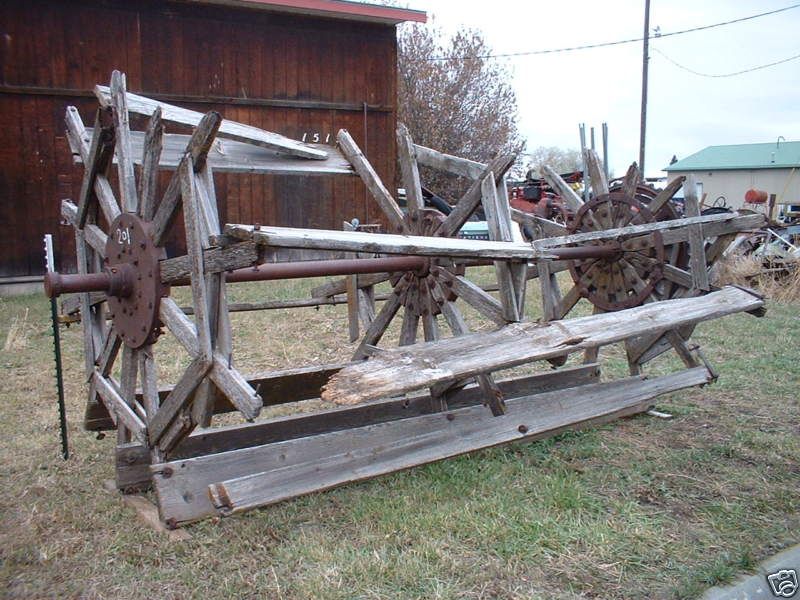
[46,72,763,527]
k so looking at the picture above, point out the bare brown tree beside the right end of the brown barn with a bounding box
[398,25,525,200]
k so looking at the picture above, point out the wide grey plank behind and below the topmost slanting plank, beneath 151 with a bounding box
[83,121,356,177]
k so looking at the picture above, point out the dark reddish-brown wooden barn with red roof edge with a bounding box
[0,0,425,283]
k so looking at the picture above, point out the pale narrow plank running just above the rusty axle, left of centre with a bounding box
[225,217,540,260]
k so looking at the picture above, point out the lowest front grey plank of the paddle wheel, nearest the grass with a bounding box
[173,368,709,521]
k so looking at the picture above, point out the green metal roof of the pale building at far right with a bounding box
[664,141,800,171]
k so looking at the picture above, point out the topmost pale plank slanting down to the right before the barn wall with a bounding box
[94,85,328,160]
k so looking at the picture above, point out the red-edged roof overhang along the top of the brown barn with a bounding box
[184,0,428,25]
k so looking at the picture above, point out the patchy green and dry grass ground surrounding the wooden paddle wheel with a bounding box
[0,274,800,600]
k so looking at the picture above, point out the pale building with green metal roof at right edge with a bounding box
[664,140,800,216]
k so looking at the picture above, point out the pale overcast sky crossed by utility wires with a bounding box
[398,0,800,177]
